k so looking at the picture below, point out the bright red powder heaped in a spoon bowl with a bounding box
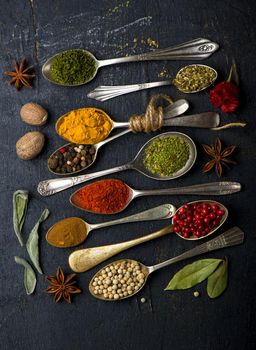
[70,179,130,214]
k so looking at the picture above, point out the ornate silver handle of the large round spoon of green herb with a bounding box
[37,163,133,197]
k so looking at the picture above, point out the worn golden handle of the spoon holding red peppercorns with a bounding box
[69,225,173,272]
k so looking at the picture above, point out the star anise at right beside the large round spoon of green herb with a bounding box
[203,138,236,176]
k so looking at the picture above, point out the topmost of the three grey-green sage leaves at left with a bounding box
[12,190,28,246]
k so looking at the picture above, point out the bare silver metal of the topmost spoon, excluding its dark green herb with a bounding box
[42,38,219,86]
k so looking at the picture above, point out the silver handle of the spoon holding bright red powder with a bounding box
[134,181,241,198]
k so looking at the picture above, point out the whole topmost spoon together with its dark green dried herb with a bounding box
[42,38,219,86]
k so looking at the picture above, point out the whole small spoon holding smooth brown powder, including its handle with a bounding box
[46,204,176,248]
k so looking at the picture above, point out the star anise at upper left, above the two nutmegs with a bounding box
[4,58,35,91]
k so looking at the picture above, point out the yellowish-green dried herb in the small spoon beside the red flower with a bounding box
[172,64,217,93]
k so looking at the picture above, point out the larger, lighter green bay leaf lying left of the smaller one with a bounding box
[165,259,222,290]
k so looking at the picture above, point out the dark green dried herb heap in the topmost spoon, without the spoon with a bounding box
[51,49,97,85]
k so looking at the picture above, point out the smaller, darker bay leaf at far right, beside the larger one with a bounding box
[207,259,228,298]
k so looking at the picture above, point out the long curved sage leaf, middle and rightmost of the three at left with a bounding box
[26,208,50,274]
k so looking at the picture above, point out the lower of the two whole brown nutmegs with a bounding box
[16,131,45,160]
